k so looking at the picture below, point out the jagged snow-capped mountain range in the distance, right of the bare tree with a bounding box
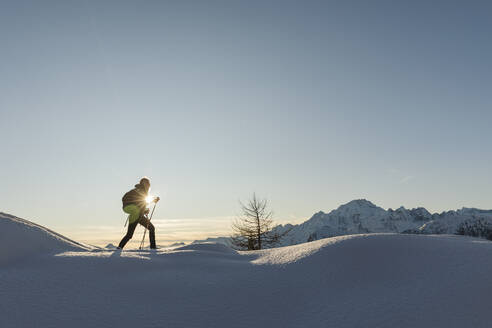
[274,199,492,246]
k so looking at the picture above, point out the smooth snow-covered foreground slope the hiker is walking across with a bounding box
[0,214,492,328]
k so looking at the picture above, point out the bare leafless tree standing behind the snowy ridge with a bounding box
[231,194,283,250]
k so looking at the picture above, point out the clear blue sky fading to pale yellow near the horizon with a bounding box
[0,0,492,244]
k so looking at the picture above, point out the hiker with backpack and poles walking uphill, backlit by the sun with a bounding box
[118,177,159,249]
